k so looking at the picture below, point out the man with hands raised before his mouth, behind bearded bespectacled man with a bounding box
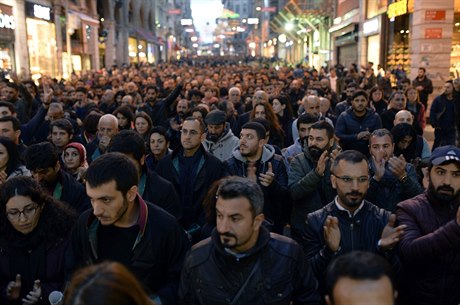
[366,129,423,212]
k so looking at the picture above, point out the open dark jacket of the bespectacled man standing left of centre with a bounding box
[156,146,226,229]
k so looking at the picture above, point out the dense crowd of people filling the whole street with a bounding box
[0,60,460,305]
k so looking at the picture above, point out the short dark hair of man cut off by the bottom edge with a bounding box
[326,251,395,301]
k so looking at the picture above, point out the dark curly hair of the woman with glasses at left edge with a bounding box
[0,176,77,244]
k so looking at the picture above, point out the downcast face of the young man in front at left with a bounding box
[86,180,137,227]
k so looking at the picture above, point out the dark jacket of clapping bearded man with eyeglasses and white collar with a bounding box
[302,200,396,282]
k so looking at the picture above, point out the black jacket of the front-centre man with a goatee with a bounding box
[179,227,320,305]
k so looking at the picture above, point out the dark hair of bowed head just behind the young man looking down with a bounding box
[107,130,145,162]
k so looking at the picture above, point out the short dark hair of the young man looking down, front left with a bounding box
[85,152,139,196]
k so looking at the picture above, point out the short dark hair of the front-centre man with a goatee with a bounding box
[216,176,264,216]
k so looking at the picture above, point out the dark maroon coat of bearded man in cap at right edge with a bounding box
[396,193,460,305]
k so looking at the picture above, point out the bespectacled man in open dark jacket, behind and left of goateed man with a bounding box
[156,117,226,242]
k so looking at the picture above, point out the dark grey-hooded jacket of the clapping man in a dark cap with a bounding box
[227,144,291,232]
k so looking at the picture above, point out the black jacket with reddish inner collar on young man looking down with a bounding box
[66,196,190,305]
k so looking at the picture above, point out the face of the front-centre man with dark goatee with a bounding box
[216,197,263,253]
